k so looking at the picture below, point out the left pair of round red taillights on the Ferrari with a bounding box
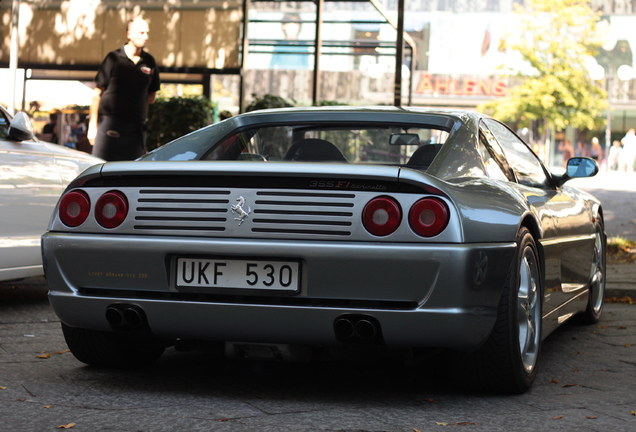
[59,190,128,228]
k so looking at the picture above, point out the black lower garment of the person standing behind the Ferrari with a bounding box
[93,116,146,161]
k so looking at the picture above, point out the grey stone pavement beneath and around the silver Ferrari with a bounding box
[0,287,636,432]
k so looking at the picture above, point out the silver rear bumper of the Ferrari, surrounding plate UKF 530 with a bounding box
[42,233,515,350]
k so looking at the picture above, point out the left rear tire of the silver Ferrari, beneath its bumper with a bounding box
[62,323,167,368]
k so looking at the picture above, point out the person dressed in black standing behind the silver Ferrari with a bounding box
[88,18,161,161]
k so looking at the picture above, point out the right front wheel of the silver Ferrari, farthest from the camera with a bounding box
[576,218,607,324]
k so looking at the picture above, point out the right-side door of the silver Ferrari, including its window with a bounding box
[484,119,593,330]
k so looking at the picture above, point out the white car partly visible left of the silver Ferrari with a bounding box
[0,106,103,281]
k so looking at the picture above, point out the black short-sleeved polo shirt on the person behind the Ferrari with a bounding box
[95,46,161,123]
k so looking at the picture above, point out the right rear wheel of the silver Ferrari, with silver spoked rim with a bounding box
[471,227,543,393]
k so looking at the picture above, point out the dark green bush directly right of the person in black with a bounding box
[146,96,215,151]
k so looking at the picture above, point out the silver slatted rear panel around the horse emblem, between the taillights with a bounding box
[134,187,356,238]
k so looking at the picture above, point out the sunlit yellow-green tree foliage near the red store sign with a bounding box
[478,0,607,129]
